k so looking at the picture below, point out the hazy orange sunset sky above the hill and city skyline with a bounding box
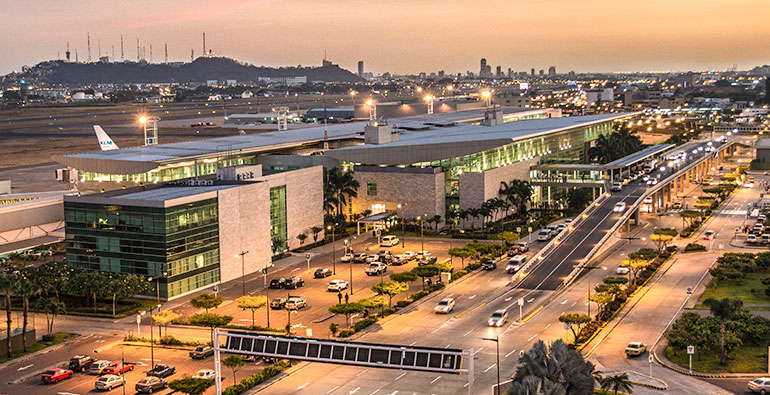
[0,0,770,74]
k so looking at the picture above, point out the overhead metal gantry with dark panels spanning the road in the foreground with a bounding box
[214,329,473,394]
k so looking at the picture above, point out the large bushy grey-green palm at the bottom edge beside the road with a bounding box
[513,339,594,394]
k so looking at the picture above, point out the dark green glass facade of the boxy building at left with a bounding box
[64,199,219,299]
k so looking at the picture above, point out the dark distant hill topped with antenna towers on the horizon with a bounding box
[0,56,363,86]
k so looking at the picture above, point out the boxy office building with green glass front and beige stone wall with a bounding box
[64,166,323,300]
